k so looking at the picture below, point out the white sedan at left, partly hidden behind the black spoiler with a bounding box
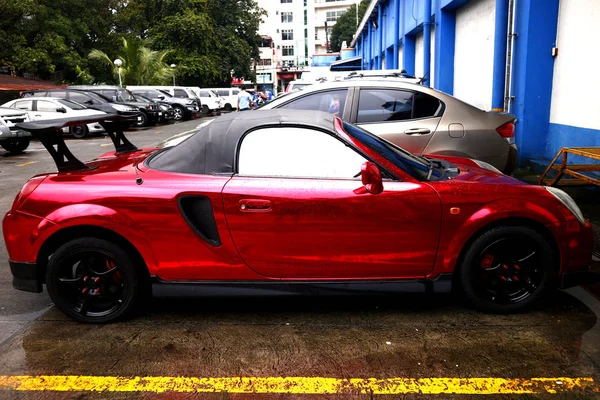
[3,97,106,139]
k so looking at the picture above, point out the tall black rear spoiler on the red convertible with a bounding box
[16,114,138,172]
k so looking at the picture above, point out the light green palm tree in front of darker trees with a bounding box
[89,38,175,85]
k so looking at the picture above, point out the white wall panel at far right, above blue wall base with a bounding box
[548,0,600,129]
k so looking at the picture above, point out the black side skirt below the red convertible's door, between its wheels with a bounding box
[152,274,452,297]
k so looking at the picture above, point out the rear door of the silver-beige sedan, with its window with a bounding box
[350,88,443,154]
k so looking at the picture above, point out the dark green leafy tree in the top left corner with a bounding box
[0,0,119,80]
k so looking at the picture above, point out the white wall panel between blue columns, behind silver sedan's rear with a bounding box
[454,0,494,110]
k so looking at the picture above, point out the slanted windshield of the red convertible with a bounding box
[343,122,431,181]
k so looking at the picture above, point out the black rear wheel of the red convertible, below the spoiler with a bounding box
[46,238,141,323]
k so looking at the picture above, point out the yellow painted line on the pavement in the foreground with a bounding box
[0,375,600,395]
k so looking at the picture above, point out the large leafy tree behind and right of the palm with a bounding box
[117,0,264,86]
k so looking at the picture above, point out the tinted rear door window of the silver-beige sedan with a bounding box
[356,89,414,123]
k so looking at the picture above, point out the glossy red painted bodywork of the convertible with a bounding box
[3,114,592,281]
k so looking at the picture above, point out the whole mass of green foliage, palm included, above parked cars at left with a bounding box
[0,0,264,86]
